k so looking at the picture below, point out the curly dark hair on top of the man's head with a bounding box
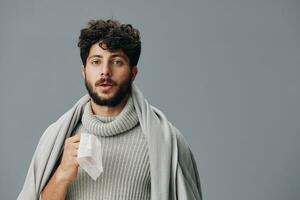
[78,19,141,67]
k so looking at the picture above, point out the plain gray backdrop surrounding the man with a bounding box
[0,0,300,200]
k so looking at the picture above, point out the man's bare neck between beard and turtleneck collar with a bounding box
[91,94,129,116]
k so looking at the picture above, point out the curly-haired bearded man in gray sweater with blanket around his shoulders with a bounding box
[18,20,202,200]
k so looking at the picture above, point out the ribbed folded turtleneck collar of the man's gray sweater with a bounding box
[81,95,138,136]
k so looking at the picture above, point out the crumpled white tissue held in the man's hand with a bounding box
[77,132,103,180]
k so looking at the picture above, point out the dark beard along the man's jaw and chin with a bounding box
[84,73,133,107]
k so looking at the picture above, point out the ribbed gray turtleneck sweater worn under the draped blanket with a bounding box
[66,96,151,200]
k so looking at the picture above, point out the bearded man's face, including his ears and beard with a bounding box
[82,43,137,107]
